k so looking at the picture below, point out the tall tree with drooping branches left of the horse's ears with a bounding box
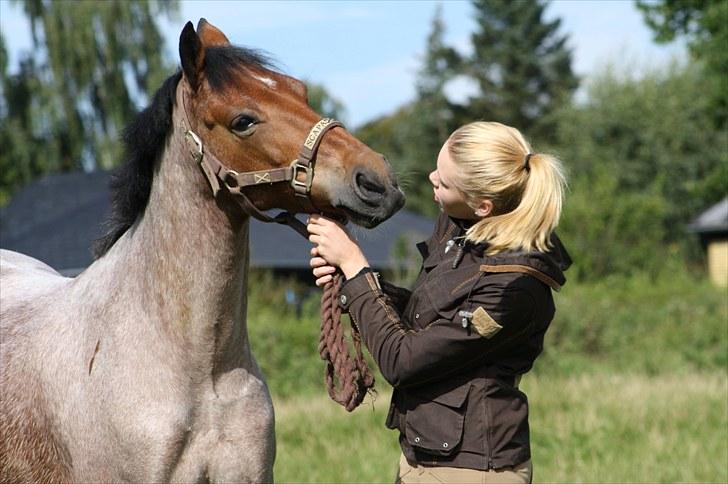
[0,0,176,205]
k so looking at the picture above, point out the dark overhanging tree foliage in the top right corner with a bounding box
[637,0,728,127]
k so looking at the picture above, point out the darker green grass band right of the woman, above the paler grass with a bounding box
[536,264,728,375]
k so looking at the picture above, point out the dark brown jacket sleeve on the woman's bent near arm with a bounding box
[340,273,535,387]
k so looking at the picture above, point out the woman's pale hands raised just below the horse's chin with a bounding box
[307,214,369,285]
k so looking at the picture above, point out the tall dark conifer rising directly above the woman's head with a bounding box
[463,0,578,136]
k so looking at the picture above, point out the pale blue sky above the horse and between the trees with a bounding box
[0,0,686,128]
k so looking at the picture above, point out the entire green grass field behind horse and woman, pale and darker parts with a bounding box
[249,266,728,483]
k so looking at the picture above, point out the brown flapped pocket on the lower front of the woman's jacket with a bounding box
[404,384,470,456]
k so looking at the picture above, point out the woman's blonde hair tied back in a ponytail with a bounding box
[448,121,566,254]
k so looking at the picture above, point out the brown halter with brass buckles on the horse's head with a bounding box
[183,92,344,238]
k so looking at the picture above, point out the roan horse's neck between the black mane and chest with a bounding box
[109,99,250,372]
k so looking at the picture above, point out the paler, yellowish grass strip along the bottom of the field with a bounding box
[275,372,728,483]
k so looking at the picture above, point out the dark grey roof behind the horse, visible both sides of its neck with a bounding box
[0,172,434,275]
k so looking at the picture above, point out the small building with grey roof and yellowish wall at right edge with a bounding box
[689,197,728,287]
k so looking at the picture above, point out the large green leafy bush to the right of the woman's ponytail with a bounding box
[552,62,728,278]
